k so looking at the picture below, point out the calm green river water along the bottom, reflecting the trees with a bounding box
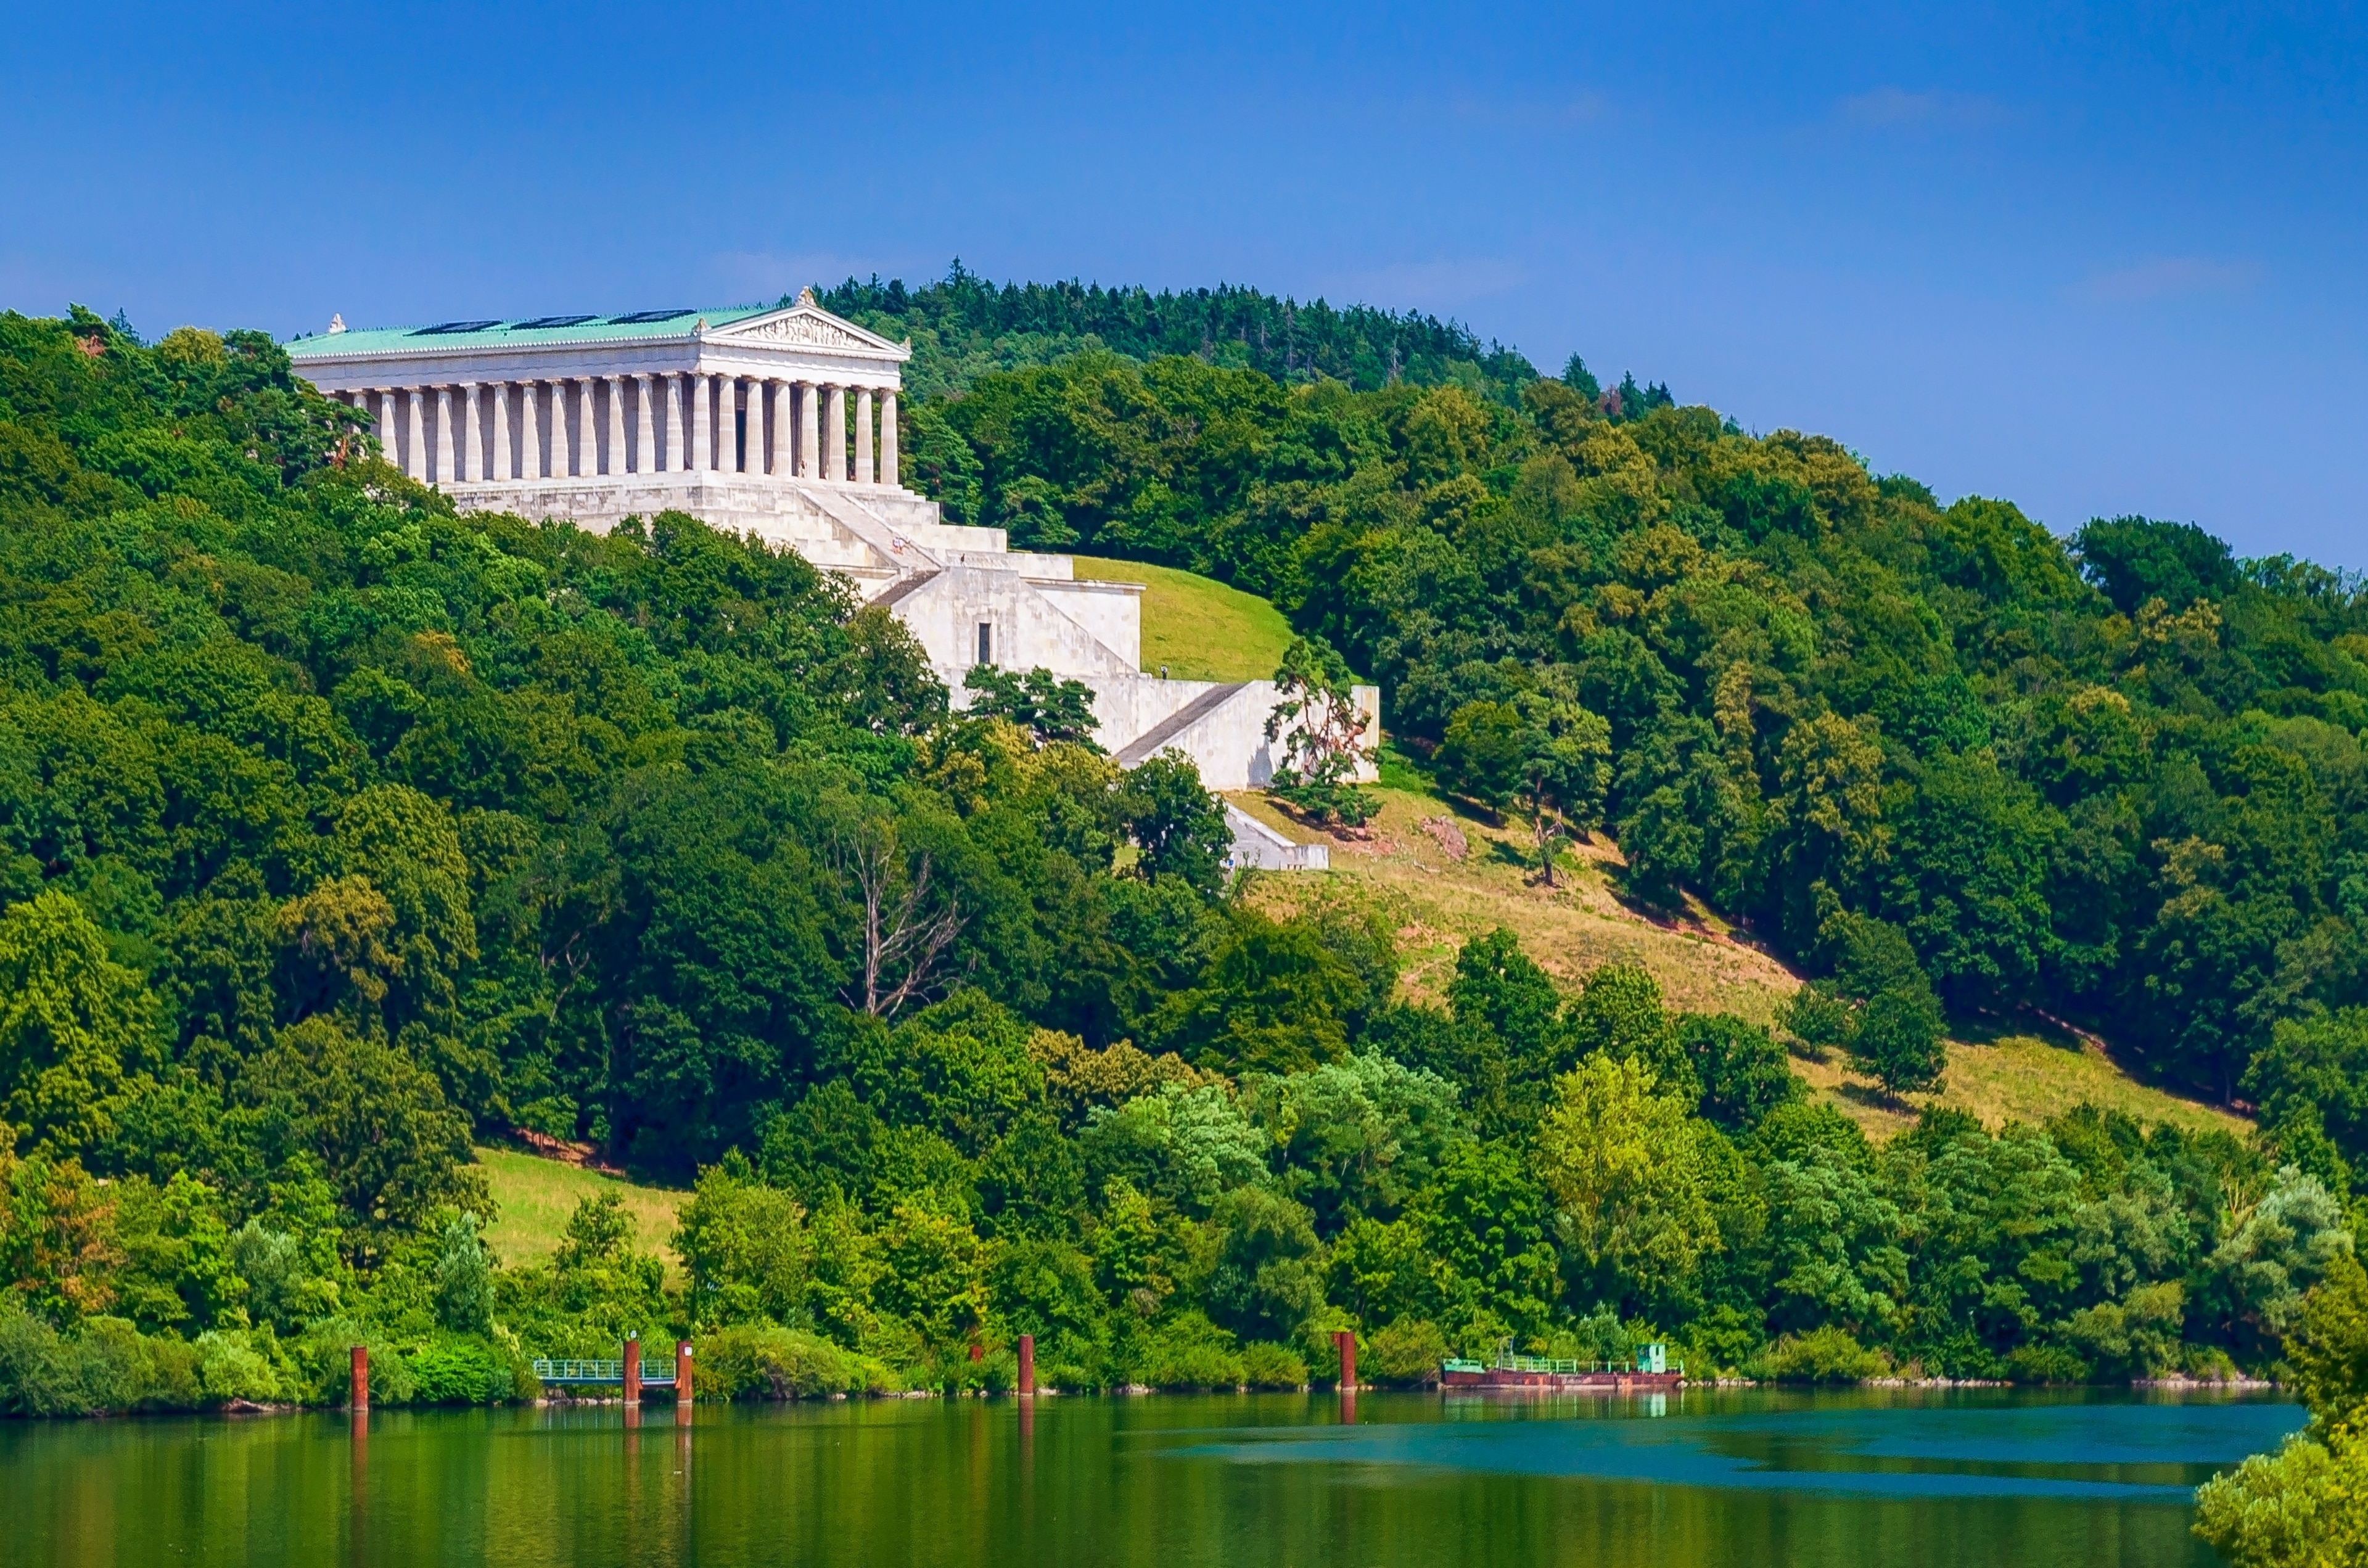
[0,1390,2301,1568]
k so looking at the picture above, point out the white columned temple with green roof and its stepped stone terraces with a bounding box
[287,293,1381,789]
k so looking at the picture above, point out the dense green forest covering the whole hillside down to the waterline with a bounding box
[0,275,2368,1414]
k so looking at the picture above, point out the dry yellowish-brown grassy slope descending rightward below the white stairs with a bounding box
[1231,770,2247,1137]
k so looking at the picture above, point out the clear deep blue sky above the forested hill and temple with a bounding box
[0,0,2368,566]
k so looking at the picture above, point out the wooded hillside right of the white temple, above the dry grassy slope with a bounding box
[866,273,2368,1177]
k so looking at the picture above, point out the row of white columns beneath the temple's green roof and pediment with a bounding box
[346,372,897,485]
